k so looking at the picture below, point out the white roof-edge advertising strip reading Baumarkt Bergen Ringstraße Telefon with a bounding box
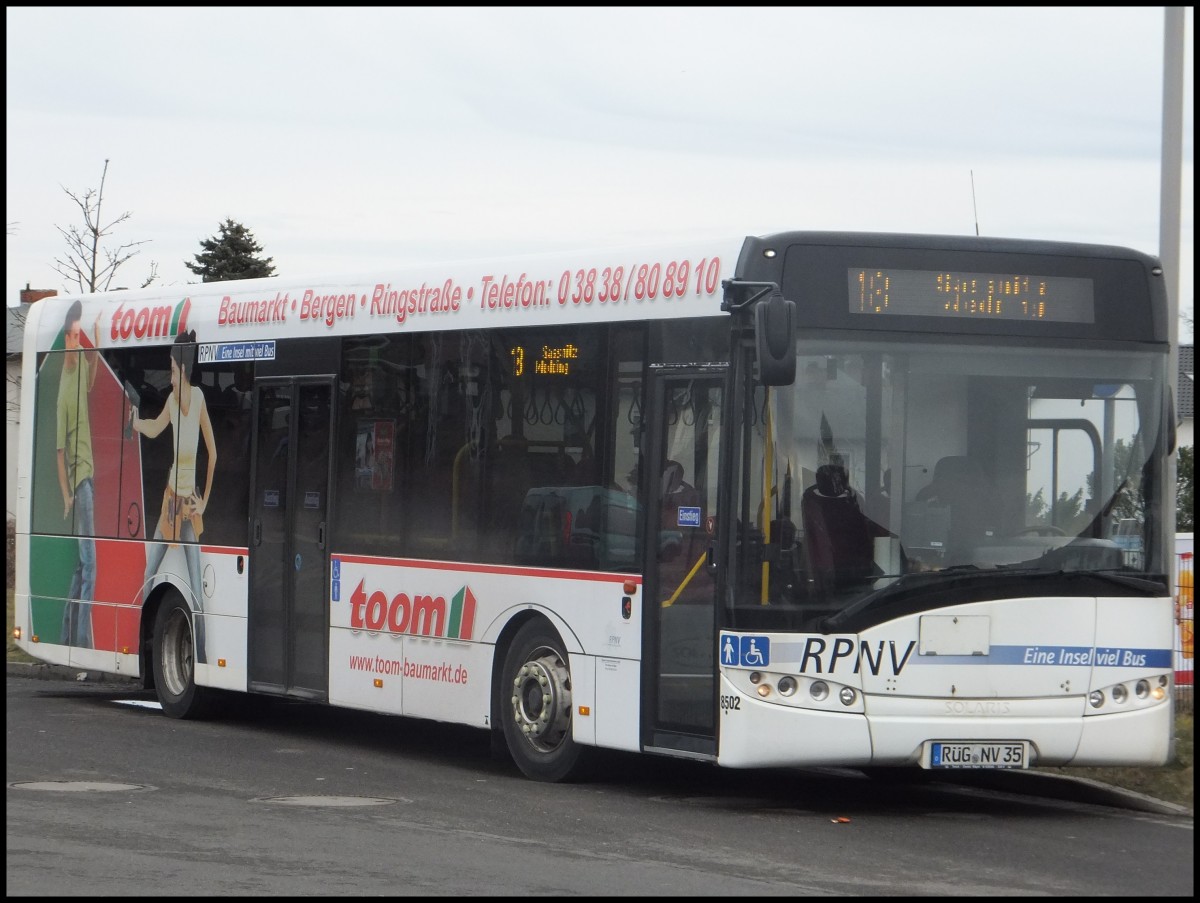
[30,237,744,363]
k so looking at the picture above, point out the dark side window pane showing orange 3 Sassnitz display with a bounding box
[486,328,643,570]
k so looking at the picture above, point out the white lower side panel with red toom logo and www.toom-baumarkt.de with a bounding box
[319,551,641,726]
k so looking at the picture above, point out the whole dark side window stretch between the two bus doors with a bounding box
[335,327,644,569]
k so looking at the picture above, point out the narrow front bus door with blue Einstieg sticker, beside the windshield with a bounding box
[643,369,725,759]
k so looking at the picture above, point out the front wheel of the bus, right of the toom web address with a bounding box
[499,620,594,782]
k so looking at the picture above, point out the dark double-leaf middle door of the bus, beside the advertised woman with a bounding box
[247,376,334,701]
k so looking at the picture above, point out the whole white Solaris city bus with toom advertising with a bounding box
[14,232,1174,781]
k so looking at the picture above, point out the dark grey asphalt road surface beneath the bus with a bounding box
[6,665,1193,897]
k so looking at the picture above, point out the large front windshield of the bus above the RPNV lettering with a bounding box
[733,341,1164,628]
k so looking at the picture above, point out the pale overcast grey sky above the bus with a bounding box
[6,7,1193,335]
